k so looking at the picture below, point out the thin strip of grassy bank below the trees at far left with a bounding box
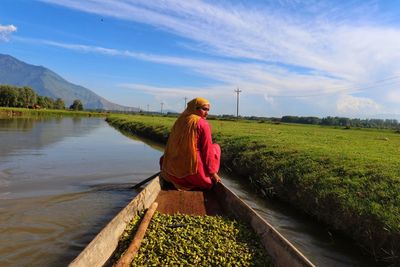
[0,107,106,117]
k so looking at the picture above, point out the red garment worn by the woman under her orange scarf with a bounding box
[160,118,221,190]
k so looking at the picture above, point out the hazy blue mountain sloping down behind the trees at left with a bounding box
[0,54,139,111]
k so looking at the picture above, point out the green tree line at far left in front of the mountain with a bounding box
[0,85,83,110]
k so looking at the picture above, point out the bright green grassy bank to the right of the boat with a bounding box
[107,115,400,263]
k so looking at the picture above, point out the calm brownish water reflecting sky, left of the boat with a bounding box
[0,118,161,266]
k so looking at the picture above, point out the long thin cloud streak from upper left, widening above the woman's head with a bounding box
[18,38,358,97]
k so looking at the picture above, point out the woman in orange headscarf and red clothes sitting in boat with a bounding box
[160,97,221,190]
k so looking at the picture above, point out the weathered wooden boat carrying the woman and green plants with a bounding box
[69,177,314,267]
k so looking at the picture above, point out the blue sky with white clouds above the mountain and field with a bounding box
[0,0,400,120]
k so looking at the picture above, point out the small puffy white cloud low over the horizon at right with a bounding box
[336,95,382,117]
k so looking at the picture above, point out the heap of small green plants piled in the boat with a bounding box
[112,212,273,266]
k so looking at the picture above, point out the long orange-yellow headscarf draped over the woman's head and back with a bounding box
[162,97,210,178]
